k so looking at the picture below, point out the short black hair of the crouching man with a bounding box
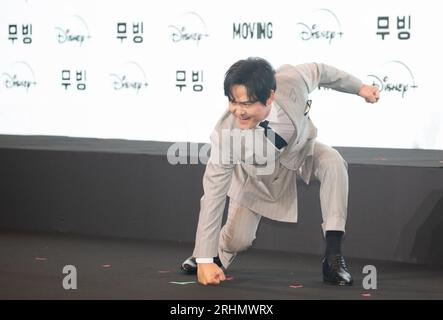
[224,57,277,104]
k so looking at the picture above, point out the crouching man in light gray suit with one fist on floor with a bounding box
[181,58,379,285]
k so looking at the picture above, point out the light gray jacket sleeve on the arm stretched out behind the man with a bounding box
[297,63,362,94]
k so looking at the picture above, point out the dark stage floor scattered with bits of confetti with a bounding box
[0,231,443,300]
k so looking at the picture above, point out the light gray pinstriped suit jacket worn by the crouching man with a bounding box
[193,63,362,257]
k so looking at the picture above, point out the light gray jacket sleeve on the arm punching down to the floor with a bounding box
[193,130,234,258]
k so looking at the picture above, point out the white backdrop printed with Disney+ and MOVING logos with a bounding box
[0,0,443,149]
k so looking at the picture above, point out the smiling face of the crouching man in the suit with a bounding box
[229,84,274,129]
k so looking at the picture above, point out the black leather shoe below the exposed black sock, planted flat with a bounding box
[323,254,354,286]
